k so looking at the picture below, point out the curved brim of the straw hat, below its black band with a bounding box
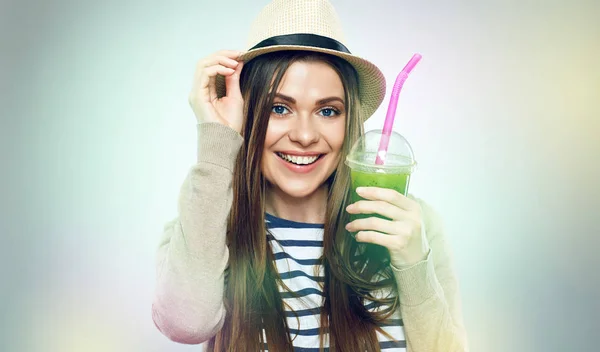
[216,45,386,122]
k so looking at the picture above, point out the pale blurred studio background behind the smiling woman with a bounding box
[0,0,600,352]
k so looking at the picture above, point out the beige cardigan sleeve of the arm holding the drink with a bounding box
[394,198,469,352]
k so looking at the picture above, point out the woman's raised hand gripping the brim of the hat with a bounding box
[189,50,244,134]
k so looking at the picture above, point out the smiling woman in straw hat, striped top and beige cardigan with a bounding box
[153,0,468,352]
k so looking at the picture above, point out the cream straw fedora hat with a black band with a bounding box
[216,0,386,122]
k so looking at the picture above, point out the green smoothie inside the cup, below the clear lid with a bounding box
[350,170,410,221]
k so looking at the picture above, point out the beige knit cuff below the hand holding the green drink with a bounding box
[394,250,442,307]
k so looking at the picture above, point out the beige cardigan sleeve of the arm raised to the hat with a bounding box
[152,124,241,344]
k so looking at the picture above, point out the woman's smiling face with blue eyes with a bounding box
[262,62,346,198]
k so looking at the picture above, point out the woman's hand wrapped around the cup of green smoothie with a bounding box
[346,187,429,268]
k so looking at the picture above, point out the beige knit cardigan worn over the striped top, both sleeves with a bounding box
[152,123,468,352]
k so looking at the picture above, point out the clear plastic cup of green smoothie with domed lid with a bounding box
[345,130,417,221]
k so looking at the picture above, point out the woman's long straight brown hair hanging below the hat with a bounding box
[208,51,399,352]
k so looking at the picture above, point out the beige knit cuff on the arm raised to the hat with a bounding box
[197,122,244,172]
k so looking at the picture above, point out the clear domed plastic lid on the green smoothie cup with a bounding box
[346,130,417,173]
